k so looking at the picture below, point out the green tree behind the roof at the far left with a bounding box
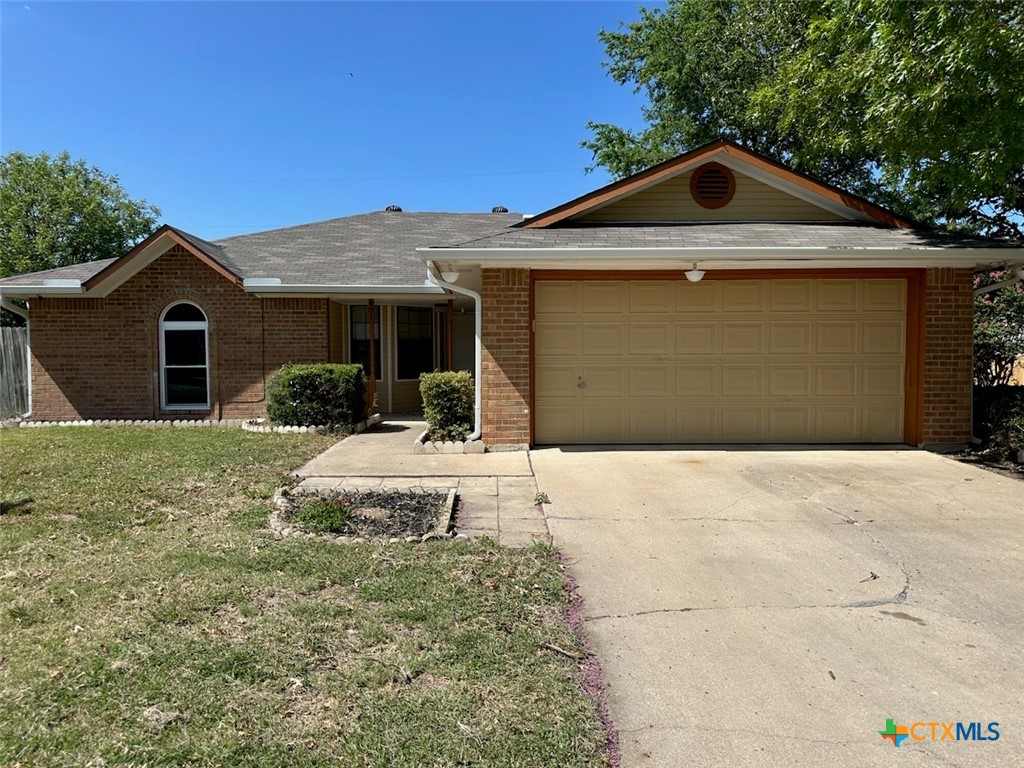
[0,152,160,278]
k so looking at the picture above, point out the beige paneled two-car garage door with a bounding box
[534,280,906,443]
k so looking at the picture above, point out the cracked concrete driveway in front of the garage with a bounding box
[531,447,1024,768]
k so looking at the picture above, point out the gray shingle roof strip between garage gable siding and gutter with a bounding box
[438,222,1021,250]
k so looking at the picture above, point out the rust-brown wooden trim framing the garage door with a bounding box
[529,268,925,445]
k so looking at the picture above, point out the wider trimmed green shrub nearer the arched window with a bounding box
[266,362,367,427]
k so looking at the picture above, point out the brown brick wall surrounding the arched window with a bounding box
[30,246,328,420]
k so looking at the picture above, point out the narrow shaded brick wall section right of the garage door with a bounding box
[923,268,974,444]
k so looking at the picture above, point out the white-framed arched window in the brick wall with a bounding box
[160,301,210,409]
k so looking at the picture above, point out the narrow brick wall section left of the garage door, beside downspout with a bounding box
[480,269,529,445]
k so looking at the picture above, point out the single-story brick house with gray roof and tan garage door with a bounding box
[0,140,1024,445]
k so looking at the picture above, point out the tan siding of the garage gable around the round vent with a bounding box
[575,171,844,221]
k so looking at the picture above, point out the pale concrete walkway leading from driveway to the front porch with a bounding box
[295,420,548,547]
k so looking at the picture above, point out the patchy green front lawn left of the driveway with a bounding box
[0,428,604,768]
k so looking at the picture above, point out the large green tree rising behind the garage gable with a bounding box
[584,0,1024,238]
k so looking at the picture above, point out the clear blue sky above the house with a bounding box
[0,0,640,239]
